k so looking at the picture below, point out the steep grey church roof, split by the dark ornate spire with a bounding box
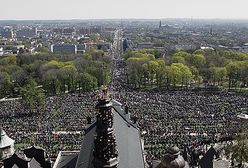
[76,100,145,168]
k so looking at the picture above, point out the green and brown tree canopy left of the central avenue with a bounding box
[0,48,111,96]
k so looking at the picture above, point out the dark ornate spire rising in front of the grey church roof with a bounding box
[93,90,118,168]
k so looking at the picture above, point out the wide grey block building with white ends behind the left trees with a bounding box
[51,44,77,54]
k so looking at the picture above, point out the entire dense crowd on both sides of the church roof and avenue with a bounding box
[0,50,248,165]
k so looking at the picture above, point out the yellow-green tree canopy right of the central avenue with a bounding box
[124,49,248,89]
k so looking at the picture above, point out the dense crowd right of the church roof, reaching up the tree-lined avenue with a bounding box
[110,50,248,164]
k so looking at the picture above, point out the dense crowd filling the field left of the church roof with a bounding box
[0,93,97,158]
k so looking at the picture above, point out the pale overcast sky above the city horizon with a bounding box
[0,0,248,20]
